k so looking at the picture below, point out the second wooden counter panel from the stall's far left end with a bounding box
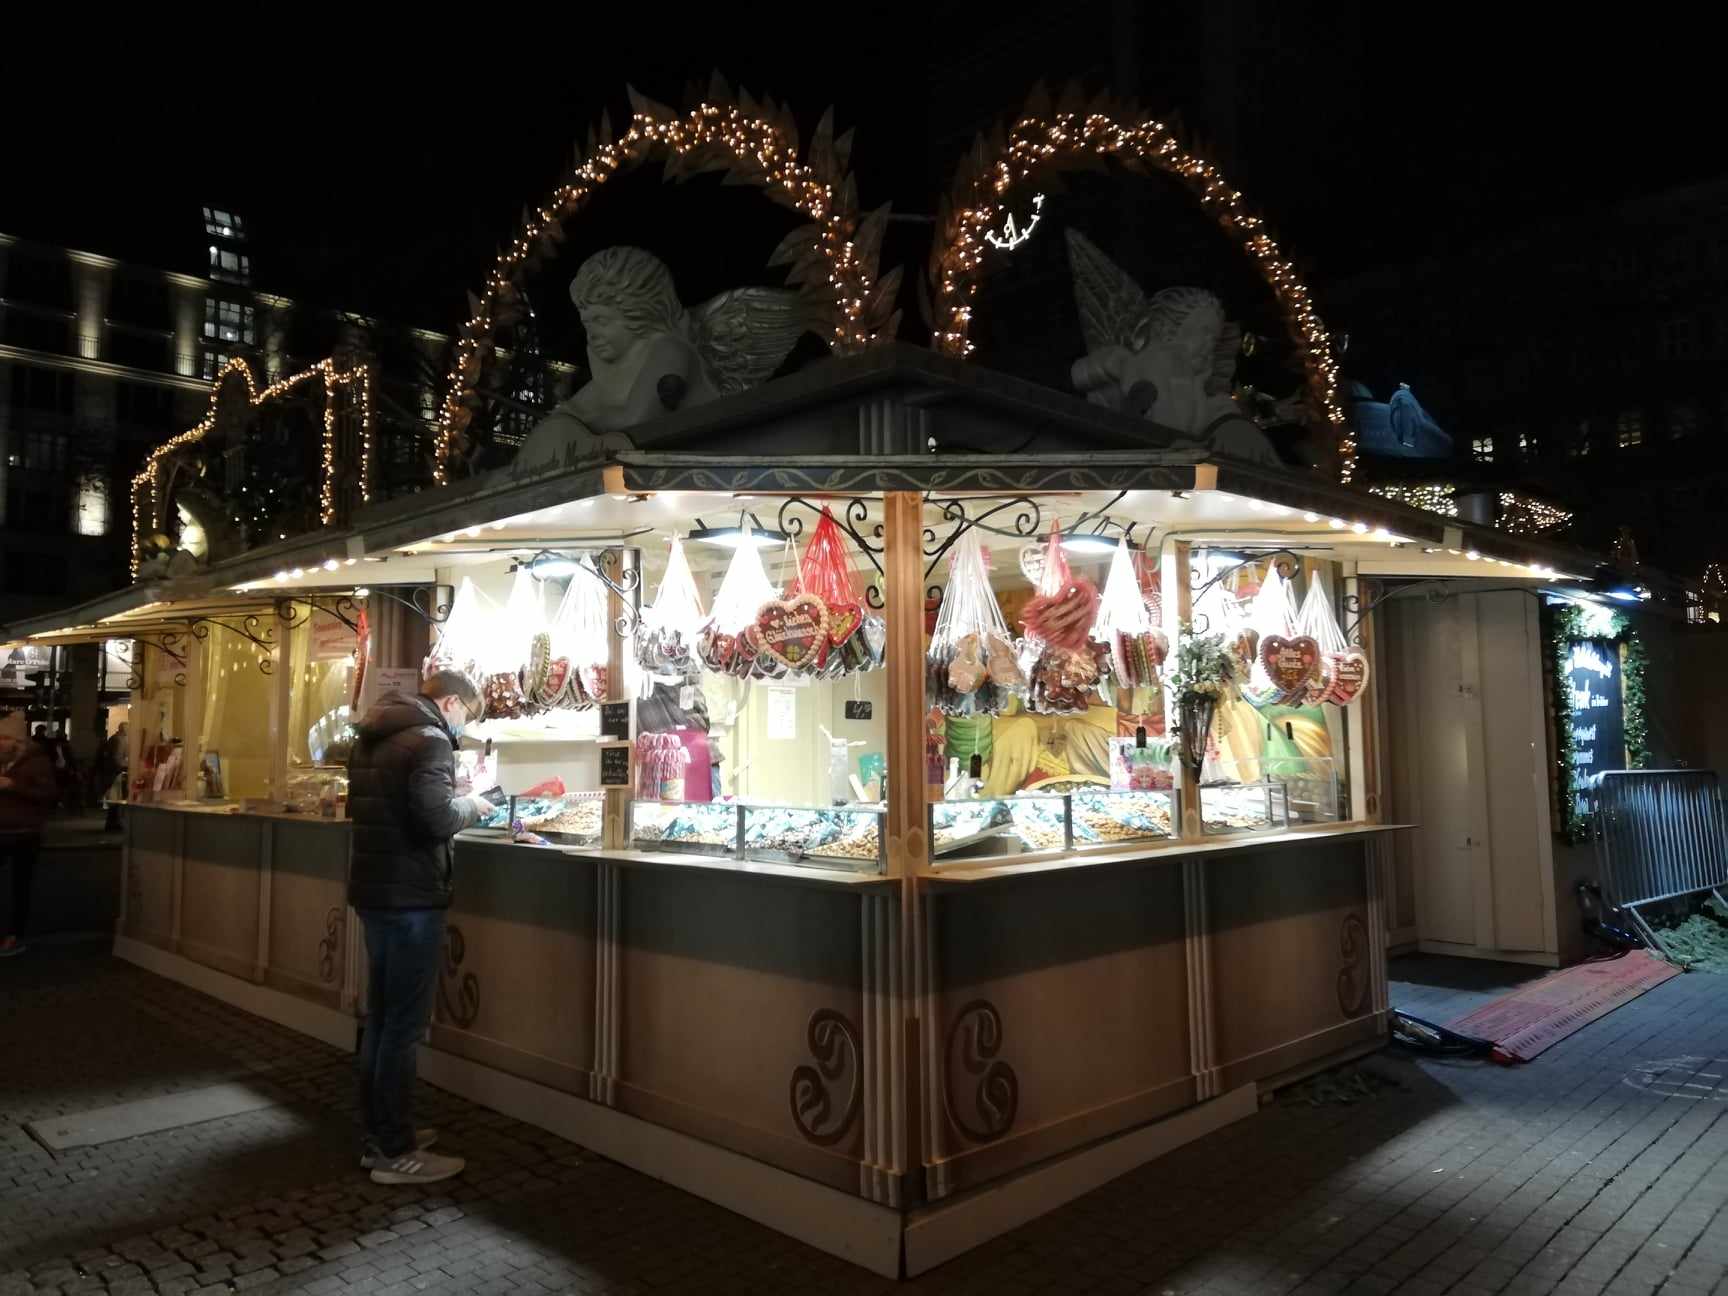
[180,814,264,978]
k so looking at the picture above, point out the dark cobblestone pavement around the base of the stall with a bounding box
[0,947,1728,1296]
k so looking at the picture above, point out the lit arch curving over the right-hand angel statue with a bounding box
[930,90,1356,482]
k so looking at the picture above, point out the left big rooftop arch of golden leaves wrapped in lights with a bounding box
[434,76,900,486]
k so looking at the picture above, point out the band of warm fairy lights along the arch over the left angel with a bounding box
[434,102,878,486]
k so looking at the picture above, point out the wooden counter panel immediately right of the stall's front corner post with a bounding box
[924,869,1194,1191]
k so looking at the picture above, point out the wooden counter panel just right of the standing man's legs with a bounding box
[434,842,594,1089]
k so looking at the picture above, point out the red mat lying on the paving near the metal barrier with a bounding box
[1448,950,1680,1063]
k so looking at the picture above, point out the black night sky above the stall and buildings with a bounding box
[0,8,1728,340]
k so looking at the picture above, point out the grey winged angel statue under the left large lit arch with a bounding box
[515,247,817,475]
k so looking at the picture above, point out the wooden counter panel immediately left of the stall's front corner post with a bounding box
[617,869,864,1168]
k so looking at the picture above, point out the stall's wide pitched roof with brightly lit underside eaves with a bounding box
[7,346,1658,643]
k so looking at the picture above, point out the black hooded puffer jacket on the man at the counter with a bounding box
[347,693,475,909]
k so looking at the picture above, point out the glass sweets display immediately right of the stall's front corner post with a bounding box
[930,786,1178,866]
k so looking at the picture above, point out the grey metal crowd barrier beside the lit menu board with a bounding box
[1593,769,1728,947]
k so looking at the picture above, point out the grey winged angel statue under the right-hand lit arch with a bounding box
[1068,230,1279,465]
